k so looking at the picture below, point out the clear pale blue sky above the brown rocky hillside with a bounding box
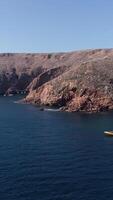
[0,0,113,52]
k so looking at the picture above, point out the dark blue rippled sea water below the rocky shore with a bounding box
[0,97,113,200]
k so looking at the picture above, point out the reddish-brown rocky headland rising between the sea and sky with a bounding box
[0,49,113,112]
